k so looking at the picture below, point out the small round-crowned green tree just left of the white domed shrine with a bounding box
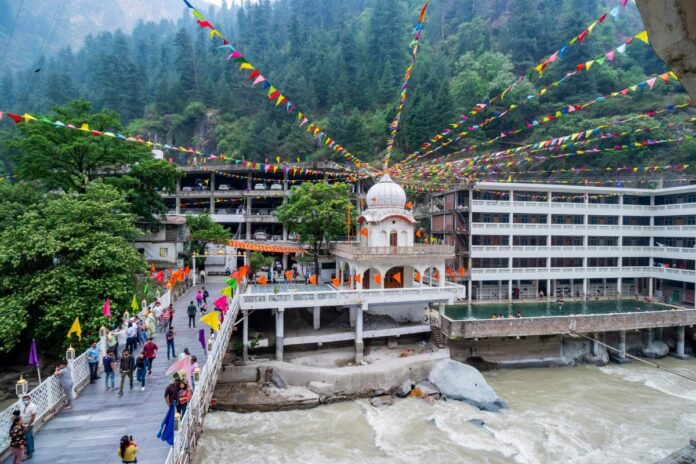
[276,182,355,280]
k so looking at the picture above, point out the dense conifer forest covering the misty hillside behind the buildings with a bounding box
[0,0,696,183]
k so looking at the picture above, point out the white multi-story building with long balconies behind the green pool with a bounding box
[448,182,696,305]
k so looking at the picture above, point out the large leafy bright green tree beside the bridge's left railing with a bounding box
[0,182,145,354]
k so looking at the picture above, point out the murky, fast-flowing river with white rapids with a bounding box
[195,359,696,464]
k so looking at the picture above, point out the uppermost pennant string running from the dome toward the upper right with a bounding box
[392,0,636,170]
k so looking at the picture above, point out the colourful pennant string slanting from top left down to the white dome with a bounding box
[183,0,368,172]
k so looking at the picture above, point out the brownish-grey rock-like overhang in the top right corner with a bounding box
[636,0,696,99]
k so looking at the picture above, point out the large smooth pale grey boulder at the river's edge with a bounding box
[428,359,505,411]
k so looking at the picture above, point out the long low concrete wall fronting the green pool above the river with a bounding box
[440,309,696,338]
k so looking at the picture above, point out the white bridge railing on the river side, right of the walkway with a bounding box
[165,288,244,464]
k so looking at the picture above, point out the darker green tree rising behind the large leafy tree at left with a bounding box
[9,100,178,227]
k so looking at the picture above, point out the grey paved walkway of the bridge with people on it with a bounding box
[6,282,224,464]
